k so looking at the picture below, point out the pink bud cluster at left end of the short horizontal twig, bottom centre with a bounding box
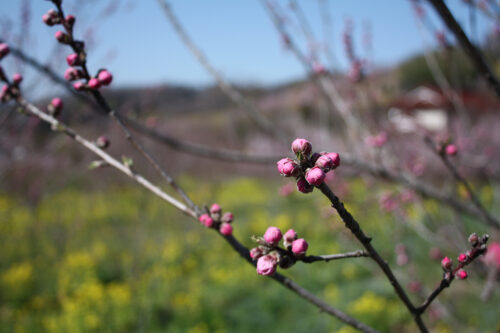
[250,227,309,275]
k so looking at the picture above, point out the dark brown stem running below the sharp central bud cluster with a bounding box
[318,183,428,332]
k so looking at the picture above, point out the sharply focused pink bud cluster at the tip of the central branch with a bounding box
[277,139,340,193]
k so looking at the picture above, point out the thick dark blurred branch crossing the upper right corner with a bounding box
[428,0,500,97]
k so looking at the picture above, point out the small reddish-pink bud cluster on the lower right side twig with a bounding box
[441,233,489,282]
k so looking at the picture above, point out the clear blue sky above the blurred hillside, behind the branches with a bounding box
[0,0,492,91]
